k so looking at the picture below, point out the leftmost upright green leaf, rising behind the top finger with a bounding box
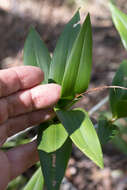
[24,28,51,83]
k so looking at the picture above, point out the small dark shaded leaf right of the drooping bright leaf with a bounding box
[98,116,119,144]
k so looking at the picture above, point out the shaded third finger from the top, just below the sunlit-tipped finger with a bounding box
[0,109,55,147]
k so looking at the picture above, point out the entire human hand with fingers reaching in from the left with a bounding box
[0,66,60,190]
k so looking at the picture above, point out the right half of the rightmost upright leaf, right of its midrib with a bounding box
[75,16,92,94]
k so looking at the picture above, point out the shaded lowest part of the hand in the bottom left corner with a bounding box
[0,141,38,190]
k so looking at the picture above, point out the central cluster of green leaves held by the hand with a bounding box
[24,12,103,190]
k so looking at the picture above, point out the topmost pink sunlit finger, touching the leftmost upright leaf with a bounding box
[0,66,44,97]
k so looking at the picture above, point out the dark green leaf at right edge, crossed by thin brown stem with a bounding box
[110,61,127,118]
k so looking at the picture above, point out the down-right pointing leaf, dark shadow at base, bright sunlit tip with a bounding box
[56,108,103,168]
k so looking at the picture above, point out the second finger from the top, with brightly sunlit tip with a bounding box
[0,84,60,124]
